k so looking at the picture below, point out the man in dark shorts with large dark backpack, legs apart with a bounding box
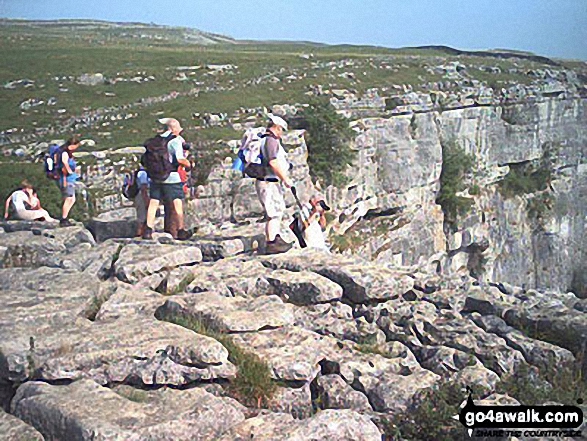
[142,118,191,240]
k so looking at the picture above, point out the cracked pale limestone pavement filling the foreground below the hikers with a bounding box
[0,223,587,440]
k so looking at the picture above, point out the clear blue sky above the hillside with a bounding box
[0,0,587,60]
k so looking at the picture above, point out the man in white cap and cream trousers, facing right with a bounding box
[255,114,293,254]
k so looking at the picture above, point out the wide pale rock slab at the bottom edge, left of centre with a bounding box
[12,380,245,441]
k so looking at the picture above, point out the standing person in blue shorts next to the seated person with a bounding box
[55,136,81,227]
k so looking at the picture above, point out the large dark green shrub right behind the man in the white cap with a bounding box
[299,100,357,186]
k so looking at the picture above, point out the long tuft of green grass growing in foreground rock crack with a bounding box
[160,315,277,407]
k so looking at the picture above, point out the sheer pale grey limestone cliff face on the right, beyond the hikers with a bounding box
[336,98,587,293]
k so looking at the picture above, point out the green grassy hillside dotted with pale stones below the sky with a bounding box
[0,20,584,153]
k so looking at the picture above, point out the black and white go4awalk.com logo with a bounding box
[455,394,583,437]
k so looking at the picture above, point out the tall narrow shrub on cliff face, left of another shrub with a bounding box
[436,140,474,227]
